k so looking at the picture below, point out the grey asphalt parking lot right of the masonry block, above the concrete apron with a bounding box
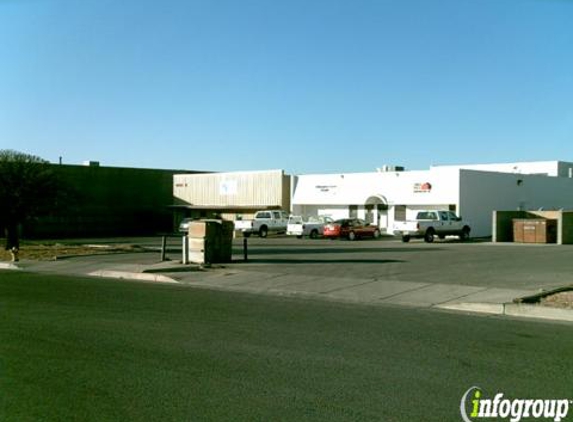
[229,236,573,289]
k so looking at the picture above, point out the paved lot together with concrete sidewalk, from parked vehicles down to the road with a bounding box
[0,237,573,321]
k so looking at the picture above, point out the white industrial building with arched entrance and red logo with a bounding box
[291,161,573,236]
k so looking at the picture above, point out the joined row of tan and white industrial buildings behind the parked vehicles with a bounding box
[173,161,573,237]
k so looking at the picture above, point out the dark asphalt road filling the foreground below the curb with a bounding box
[0,271,573,422]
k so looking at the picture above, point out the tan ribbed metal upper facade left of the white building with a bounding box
[173,170,291,211]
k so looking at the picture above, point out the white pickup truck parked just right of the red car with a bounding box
[394,210,471,242]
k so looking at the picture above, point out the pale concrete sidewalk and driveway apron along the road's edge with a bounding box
[0,253,573,321]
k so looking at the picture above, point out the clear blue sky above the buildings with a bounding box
[0,0,573,173]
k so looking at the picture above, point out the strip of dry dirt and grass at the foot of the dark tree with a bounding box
[0,243,143,261]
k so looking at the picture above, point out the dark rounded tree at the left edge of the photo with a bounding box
[0,150,59,261]
